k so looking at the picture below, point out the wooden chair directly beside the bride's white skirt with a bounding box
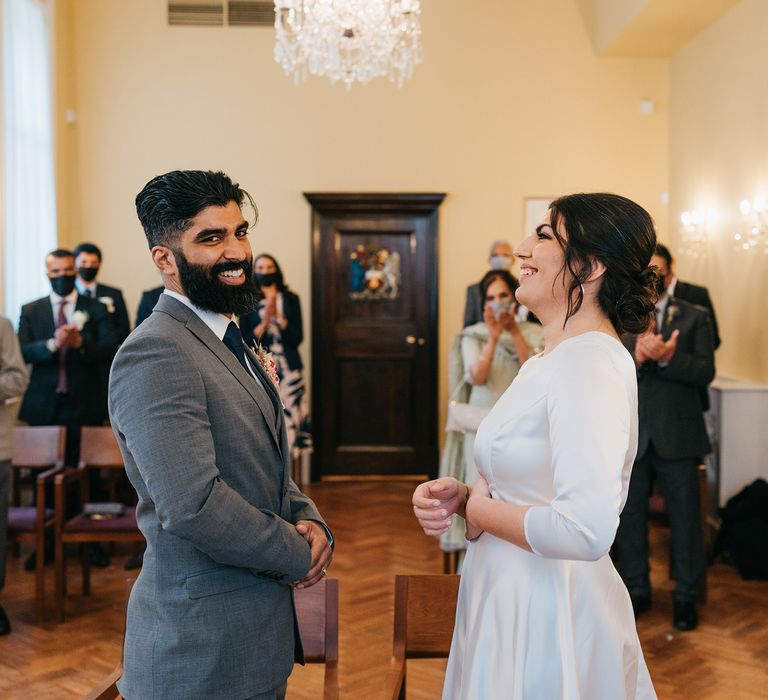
[381,574,460,700]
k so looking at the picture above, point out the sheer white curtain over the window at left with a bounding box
[0,0,57,323]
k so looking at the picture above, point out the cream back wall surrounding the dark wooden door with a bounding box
[60,0,668,440]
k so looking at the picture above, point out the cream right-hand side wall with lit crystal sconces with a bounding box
[669,0,768,382]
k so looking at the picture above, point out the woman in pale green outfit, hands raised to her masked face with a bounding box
[440,270,544,568]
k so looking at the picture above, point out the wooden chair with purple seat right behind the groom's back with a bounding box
[54,426,144,622]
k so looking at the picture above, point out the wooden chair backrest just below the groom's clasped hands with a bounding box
[294,578,339,663]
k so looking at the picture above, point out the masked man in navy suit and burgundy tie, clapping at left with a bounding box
[19,249,118,568]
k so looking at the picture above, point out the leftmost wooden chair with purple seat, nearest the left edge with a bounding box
[8,426,66,622]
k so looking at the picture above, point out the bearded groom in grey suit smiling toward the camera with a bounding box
[109,171,332,700]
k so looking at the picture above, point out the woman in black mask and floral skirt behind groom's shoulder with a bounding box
[240,253,312,460]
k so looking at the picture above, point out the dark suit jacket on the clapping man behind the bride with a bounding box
[623,298,715,459]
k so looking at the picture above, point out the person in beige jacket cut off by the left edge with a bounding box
[0,318,29,635]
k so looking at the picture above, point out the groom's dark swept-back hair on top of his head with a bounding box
[136,170,258,250]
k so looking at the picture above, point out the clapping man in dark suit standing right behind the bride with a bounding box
[614,249,715,631]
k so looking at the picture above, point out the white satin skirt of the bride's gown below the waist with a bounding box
[443,533,656,700]
